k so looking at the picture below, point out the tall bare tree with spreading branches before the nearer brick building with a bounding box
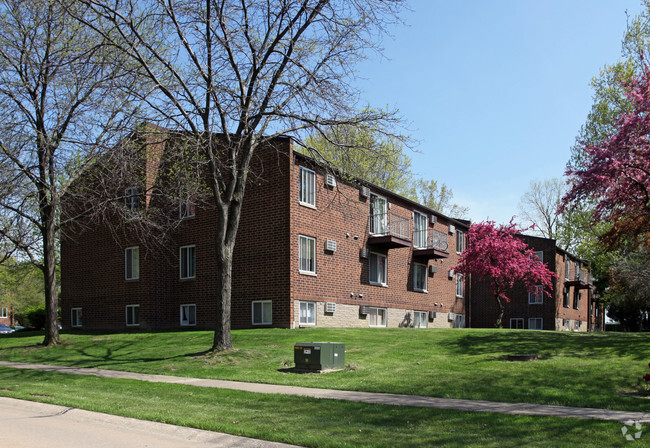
[76,0,403,350]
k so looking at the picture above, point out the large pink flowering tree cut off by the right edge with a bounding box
[560,66,650,247]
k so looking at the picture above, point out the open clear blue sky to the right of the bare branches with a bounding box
[357,0,641,222]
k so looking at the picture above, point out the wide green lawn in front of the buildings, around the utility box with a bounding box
[0,329,650,412]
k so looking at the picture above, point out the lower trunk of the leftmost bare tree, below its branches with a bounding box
[43,213,61,347]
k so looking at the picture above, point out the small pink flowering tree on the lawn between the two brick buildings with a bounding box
[454,221,556,328]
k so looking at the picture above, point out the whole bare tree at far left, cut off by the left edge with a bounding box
[0,0,135,345]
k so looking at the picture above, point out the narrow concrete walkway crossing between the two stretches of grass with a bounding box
[0,361,650,423]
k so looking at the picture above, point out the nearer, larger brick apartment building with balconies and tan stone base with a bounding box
[61,131,469,330]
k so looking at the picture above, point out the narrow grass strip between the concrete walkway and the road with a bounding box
[0,368,628,448]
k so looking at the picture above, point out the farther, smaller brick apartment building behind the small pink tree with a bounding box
[469,235,605,331]
